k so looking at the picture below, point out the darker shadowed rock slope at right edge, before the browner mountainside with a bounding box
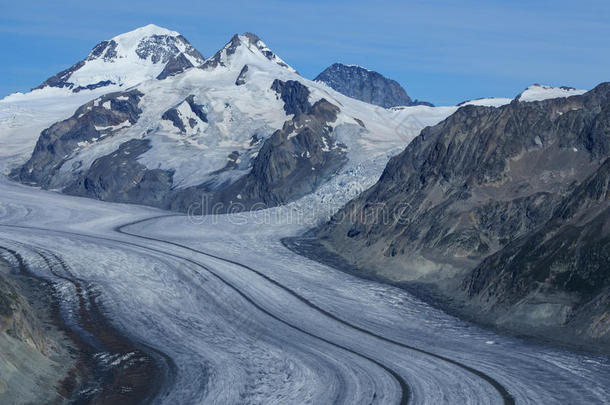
[463,158,610,343]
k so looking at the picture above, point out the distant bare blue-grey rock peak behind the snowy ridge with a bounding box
[314,63,431,108]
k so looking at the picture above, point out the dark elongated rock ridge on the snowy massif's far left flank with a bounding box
[11,90,143,187]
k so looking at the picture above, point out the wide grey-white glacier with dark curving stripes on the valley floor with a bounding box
[0,178,610,404]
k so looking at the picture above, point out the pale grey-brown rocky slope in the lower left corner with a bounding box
[0,252,80,404]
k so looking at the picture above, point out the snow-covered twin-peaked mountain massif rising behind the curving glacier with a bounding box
[7,26,580,212]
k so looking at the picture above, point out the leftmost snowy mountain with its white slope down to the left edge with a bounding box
[0,24,204,171]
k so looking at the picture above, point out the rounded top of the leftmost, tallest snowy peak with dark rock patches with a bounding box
[36,24,204,93]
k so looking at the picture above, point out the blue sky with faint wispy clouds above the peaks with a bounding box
[0,0,610,104]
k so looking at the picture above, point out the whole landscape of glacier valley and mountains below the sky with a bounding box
[0,24,610,405]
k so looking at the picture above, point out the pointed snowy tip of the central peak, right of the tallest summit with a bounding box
[201,32,295,72]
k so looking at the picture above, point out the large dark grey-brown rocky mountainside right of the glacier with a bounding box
[318,83,610,348]
